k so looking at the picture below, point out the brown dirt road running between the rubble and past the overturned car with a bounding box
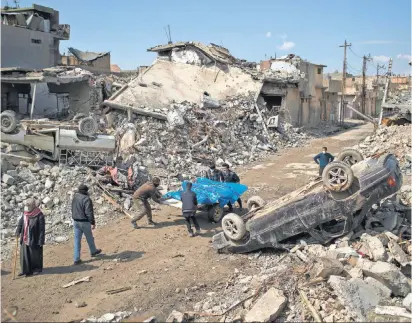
[2,124,372,321]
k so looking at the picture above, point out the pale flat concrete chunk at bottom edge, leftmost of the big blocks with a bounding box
[245,287,287,322]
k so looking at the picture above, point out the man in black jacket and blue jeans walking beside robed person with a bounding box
[72,184,102,265]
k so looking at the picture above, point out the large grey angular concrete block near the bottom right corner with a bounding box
[328,276,381,321]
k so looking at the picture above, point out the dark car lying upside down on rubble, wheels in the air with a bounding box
[213,149,402,253]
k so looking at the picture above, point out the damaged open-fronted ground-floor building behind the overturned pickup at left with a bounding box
[1,67,101,118]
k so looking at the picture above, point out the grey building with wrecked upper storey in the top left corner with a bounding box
[1,4,70,69]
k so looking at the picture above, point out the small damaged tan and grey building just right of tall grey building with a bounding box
[61,47,111,73]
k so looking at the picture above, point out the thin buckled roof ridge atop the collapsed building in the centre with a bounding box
[147,41,236,64]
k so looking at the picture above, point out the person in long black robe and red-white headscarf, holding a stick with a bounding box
[16,198,46,277]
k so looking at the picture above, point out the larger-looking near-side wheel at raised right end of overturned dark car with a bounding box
[322,161,355,192]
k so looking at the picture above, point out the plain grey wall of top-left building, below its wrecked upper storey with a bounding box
[1,25,58,69]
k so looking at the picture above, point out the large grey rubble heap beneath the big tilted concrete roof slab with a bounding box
[112,96,342,185]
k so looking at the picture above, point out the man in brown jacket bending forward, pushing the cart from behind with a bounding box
[131,177,162,229]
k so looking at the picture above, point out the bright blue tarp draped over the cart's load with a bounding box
[163,177,248,207]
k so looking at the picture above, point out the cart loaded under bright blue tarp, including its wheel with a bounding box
[163,177,248,223]
